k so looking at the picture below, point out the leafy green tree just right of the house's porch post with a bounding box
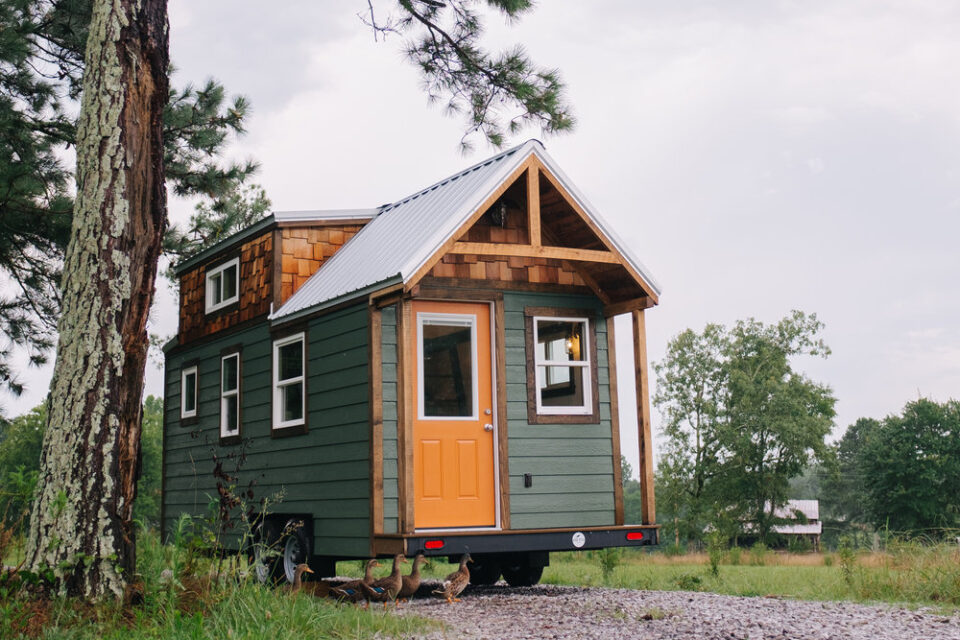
[654,311,835,540]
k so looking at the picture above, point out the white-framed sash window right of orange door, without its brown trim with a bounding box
[533,316,593,416]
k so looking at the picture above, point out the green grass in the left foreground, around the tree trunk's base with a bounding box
[0,534,436,640]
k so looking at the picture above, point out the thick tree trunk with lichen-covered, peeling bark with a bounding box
[27,0,168,598]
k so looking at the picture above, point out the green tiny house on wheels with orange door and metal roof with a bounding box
[162,140,660,585]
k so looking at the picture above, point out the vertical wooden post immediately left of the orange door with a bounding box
[397,300,416,533]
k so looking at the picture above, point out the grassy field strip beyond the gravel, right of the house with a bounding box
[542,543,960,611]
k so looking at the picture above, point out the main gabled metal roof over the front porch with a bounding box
[270,140,660,320]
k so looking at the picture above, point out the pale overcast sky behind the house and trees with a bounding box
[2,0,960,476]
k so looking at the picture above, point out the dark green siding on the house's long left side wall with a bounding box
[164,304,370,556]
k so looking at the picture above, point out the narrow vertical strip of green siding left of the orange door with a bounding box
[380,305,399,533]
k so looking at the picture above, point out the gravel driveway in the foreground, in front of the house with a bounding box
[400,585,960,640]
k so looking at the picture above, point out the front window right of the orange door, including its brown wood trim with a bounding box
[525,307,600,424]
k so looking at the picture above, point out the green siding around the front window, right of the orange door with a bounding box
[503,292,619,529]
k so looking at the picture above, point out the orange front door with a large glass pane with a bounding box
[413,301,496,529]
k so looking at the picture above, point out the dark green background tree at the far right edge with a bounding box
[857,398,960,537]
